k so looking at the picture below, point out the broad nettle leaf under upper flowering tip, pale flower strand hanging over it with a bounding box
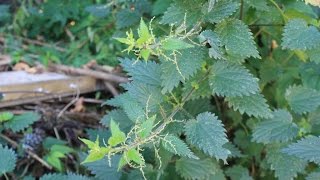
[161,47,206,93]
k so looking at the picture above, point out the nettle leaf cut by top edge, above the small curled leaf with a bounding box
[205,0,240,23]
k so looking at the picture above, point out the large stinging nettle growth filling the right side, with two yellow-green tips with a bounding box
[81,0,320,179]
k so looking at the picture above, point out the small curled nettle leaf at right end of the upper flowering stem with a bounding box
[199,30,224,59]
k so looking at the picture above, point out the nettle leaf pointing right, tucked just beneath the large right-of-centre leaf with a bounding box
[226,93,272,118]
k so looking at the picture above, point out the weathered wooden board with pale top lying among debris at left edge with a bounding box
[0,71,98,108]
